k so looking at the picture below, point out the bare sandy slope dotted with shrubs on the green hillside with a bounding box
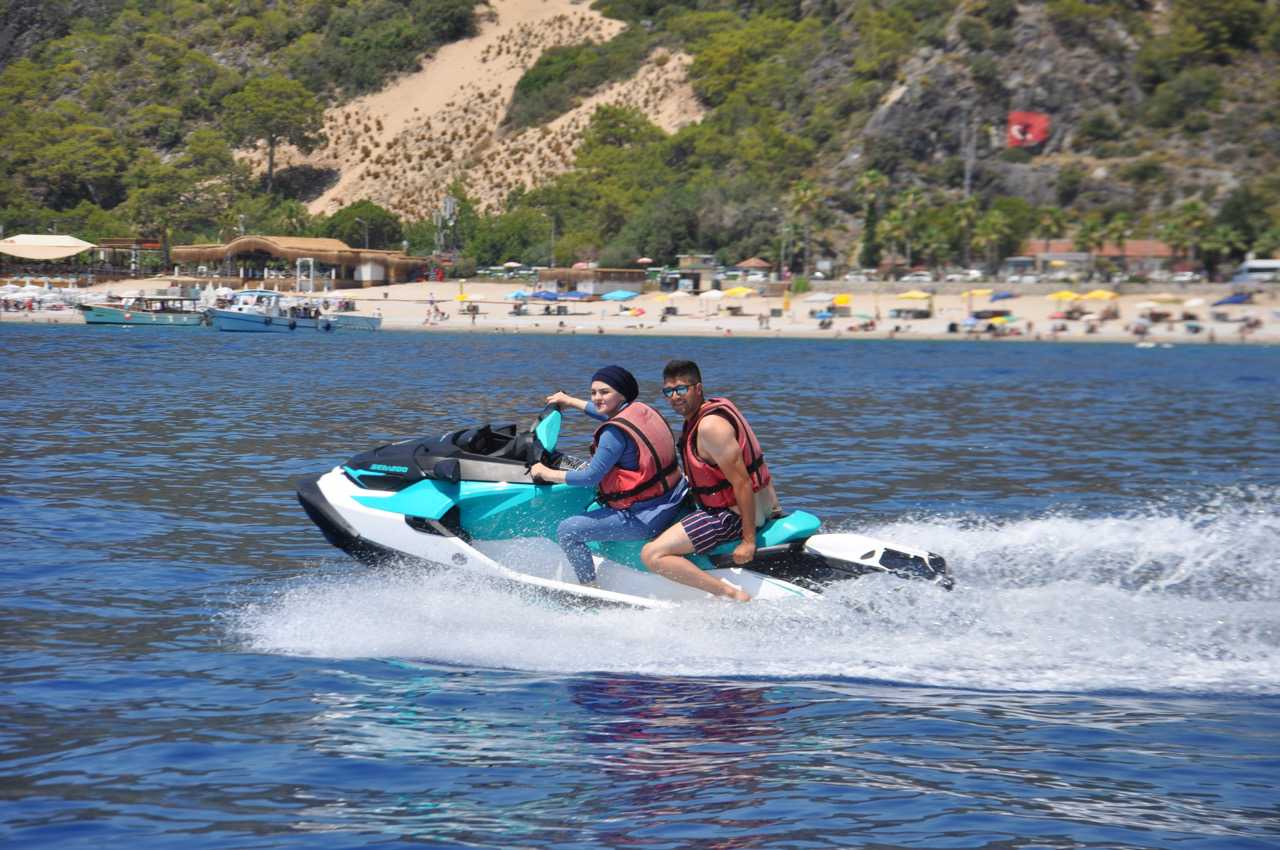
[267,0,703,220]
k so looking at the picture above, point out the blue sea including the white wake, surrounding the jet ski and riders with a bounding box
[0,324,1280,850]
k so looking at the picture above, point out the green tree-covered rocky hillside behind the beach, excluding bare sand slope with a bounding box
[0,0,1280,277]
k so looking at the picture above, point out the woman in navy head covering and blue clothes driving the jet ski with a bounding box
[529,366,687,585]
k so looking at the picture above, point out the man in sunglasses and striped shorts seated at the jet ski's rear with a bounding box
[640,360,781,602]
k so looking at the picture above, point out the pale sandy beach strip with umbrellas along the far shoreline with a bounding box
[10,278,1280,344]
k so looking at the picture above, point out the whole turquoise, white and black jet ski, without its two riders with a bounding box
[297,407,952,608]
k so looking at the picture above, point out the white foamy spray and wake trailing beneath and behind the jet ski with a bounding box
[234,491,1280,694]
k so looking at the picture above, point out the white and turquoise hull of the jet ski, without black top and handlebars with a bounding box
[297,465,950,608]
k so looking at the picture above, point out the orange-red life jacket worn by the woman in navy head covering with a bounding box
[591,402,680,509]
